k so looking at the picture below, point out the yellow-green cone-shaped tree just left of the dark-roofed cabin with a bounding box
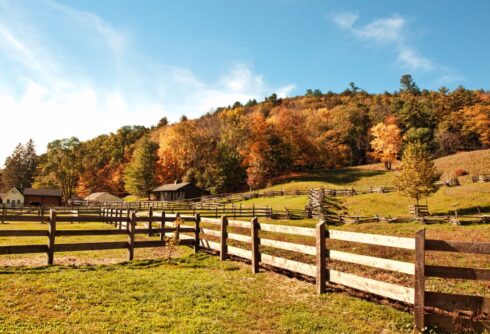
[124,136,158,200]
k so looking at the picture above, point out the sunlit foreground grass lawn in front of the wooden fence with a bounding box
[0,249,413,333]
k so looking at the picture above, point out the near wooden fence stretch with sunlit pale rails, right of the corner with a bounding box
[192,217,490,331]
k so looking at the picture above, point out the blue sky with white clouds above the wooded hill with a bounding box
[0,0,490,164]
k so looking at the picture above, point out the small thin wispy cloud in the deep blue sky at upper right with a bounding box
[331,12,438,71]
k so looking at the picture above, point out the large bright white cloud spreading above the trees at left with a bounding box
[0,0,294,164]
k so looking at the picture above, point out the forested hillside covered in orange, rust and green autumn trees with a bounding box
[1,75,490,198]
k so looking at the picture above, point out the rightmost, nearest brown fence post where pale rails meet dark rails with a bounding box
[414,229,425,332]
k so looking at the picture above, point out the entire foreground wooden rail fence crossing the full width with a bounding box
[0,208,490,331]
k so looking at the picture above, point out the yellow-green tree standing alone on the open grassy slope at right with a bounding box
[395,142,441,205]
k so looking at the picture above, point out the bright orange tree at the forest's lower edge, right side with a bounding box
[371,123,402,170]
